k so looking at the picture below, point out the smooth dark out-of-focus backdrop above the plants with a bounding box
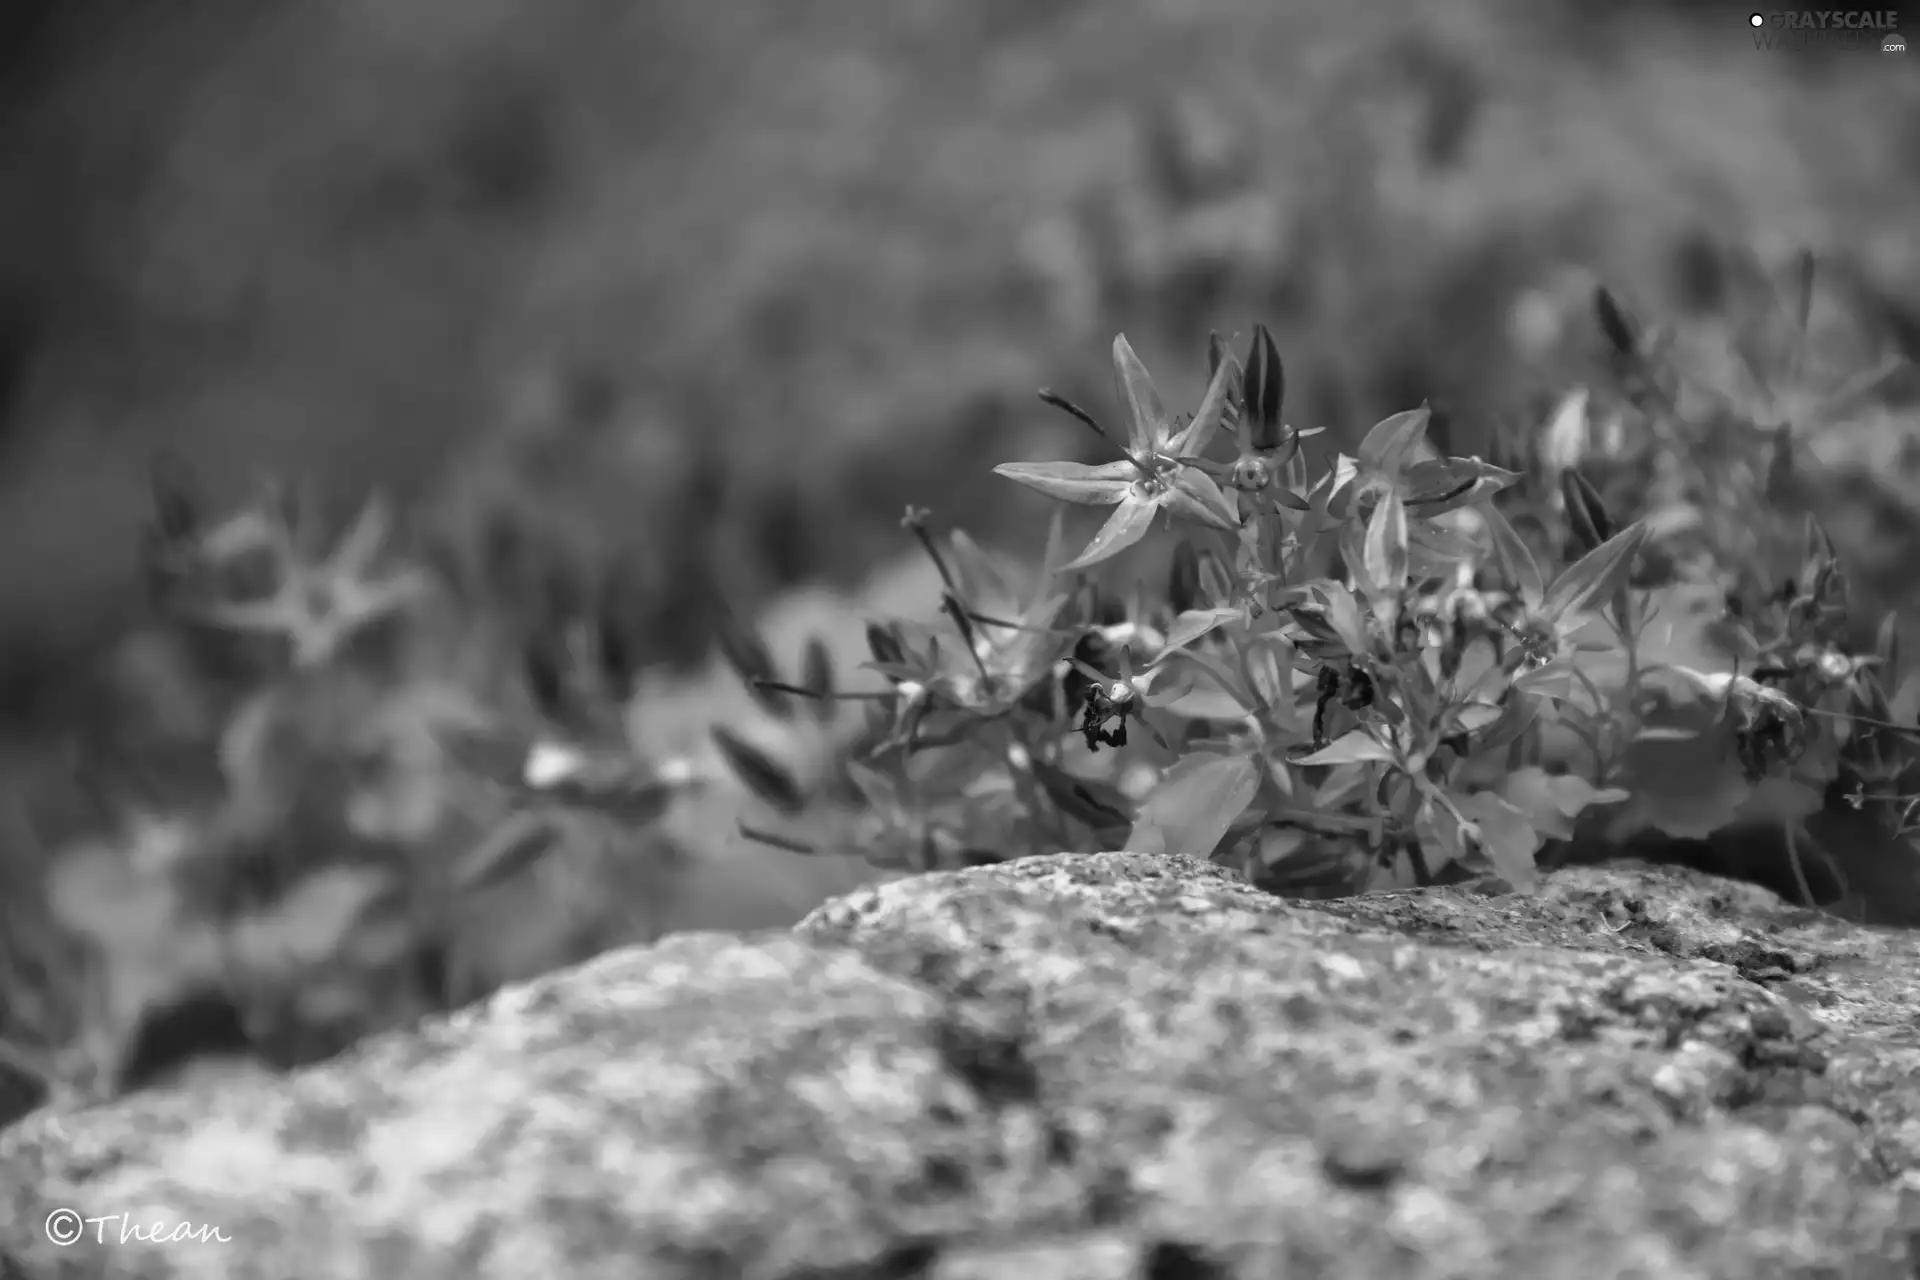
[0,0,1920,923]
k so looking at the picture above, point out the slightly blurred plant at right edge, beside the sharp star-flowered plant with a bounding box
[1530,253,1920,894]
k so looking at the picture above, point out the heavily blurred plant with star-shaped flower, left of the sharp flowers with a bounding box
[0,468,699,1098]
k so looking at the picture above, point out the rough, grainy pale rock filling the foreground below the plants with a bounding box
[0,854,1920,1280]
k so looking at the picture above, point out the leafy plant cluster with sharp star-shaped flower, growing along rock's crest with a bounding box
[725,280,1920,894]
